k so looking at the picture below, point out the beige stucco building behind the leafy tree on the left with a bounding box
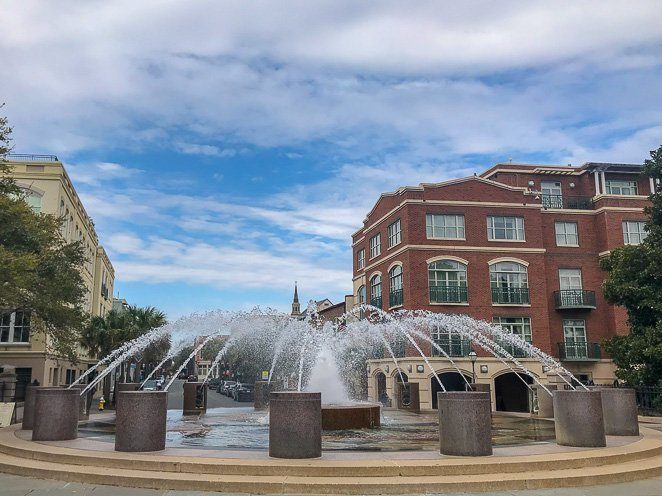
[0,155,115,393]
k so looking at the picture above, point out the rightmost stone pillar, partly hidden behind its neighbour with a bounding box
[600,388,639,436]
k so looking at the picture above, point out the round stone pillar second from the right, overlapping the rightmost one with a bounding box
[554,389,607,448]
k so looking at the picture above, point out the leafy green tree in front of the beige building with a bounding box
[0,109,87,362]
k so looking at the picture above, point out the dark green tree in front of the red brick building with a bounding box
[602,146,662,386]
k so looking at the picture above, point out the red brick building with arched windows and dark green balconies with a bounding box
[352,163,654,409]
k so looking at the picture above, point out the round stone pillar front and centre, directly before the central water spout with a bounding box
[269,391,322,458]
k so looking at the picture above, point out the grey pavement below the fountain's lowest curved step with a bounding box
[0,474,662,496]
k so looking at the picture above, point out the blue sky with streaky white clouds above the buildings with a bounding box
[0,0,662,318]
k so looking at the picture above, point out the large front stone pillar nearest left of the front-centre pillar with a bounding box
[115,391,168,452]
